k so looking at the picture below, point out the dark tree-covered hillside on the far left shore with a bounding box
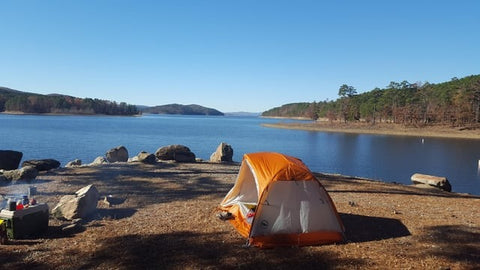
[0,87,139,115]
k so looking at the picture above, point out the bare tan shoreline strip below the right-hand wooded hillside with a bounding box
[262,121,480,140]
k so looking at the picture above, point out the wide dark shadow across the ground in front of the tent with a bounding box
[70,231,364,269]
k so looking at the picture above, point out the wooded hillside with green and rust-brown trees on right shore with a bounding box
[262,75,480,126]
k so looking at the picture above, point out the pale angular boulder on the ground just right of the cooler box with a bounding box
[52,185,100,220]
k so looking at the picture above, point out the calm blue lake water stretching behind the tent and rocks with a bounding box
[0,115,480,195]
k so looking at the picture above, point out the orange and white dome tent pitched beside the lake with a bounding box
[220,152,344,247]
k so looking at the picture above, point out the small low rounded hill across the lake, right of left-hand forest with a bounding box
[142,103,224,116]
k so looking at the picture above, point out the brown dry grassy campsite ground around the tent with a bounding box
[0,163,480,269]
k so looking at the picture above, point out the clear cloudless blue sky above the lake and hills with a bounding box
[0,0,480,112]
